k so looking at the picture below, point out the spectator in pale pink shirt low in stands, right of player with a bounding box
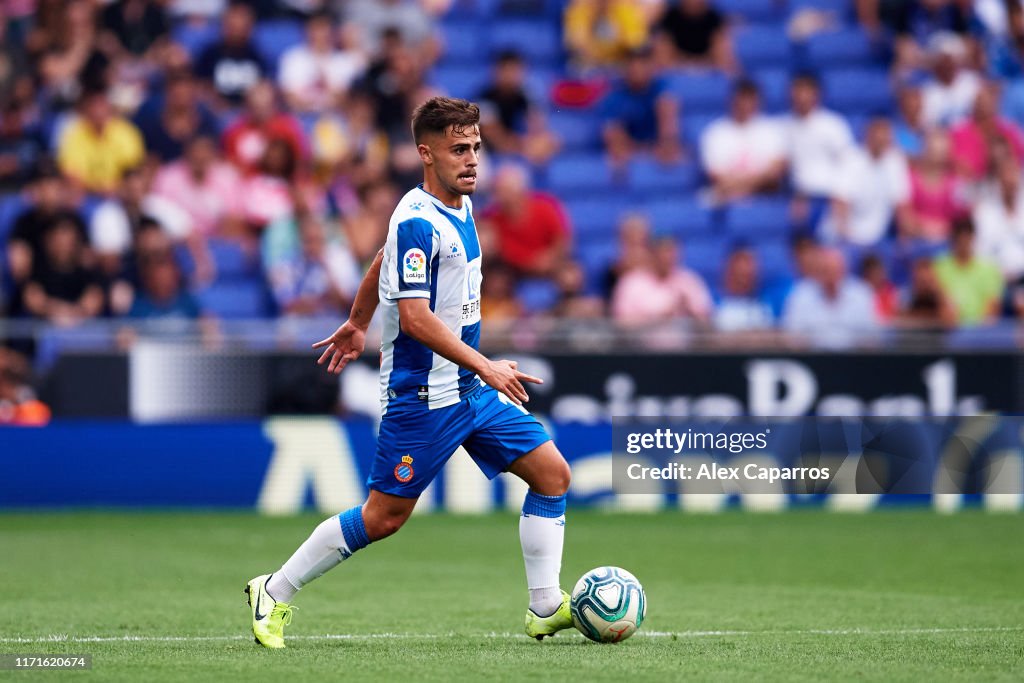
[611,237,712,326]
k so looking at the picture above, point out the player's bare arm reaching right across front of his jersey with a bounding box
[398,298,544,405]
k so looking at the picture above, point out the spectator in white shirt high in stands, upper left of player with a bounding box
[279,12,367,112]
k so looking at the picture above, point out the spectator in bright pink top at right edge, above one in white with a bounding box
[951,87,1024,180]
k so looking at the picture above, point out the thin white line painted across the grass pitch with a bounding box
[0,626,1024,644]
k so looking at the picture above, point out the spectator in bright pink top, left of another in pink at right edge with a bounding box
[900,130,967,242]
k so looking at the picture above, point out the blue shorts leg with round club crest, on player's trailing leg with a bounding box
[367,402,472,499]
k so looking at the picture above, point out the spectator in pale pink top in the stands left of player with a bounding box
[153,136,246,237]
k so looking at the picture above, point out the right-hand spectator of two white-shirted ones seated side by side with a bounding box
[786,74,854,198]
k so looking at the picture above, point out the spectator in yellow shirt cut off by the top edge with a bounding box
[565,0,647,67]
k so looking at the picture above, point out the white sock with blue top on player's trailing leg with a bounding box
[266,508,369,602]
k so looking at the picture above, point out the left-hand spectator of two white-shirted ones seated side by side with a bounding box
[700,80,785,202]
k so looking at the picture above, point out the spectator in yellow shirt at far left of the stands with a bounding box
[57,92,145,194]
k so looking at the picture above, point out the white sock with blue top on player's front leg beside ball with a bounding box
[519,492,565,616]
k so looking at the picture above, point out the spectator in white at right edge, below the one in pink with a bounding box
[974,153,1024,281]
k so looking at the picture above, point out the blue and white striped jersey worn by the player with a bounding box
[379,185,482,413]
